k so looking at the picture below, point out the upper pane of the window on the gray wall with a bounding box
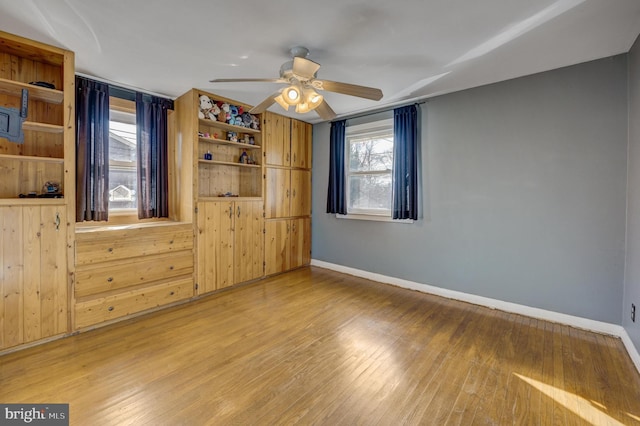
[349,134,393,172]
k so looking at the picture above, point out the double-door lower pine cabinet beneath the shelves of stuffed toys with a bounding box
[197,201,264,294]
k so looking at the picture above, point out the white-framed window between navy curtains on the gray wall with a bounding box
[345,119,393,217]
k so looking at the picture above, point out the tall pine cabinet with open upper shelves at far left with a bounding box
[0,31,75,350]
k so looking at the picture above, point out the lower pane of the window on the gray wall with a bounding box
[347,174,391,212]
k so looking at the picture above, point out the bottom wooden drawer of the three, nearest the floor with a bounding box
[75,277,193,329]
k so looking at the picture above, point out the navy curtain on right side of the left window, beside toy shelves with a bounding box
[136,93,173,219]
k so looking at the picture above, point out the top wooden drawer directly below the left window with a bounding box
[76,224,193,265]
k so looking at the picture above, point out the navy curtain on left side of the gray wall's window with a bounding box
[327,120,347,214]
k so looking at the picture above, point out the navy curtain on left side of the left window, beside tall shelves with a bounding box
[76,76,109,222]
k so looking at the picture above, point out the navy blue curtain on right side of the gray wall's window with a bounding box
[392,105,418,220]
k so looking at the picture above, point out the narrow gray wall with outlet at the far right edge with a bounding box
[622,38,640,352]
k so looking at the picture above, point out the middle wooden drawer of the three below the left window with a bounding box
[75,250,193,299]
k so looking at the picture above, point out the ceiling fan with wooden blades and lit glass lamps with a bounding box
[209,46,382,120]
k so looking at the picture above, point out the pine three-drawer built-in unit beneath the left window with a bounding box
[74,222,194,329]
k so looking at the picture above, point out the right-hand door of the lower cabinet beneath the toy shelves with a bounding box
[234,201,264,283]
